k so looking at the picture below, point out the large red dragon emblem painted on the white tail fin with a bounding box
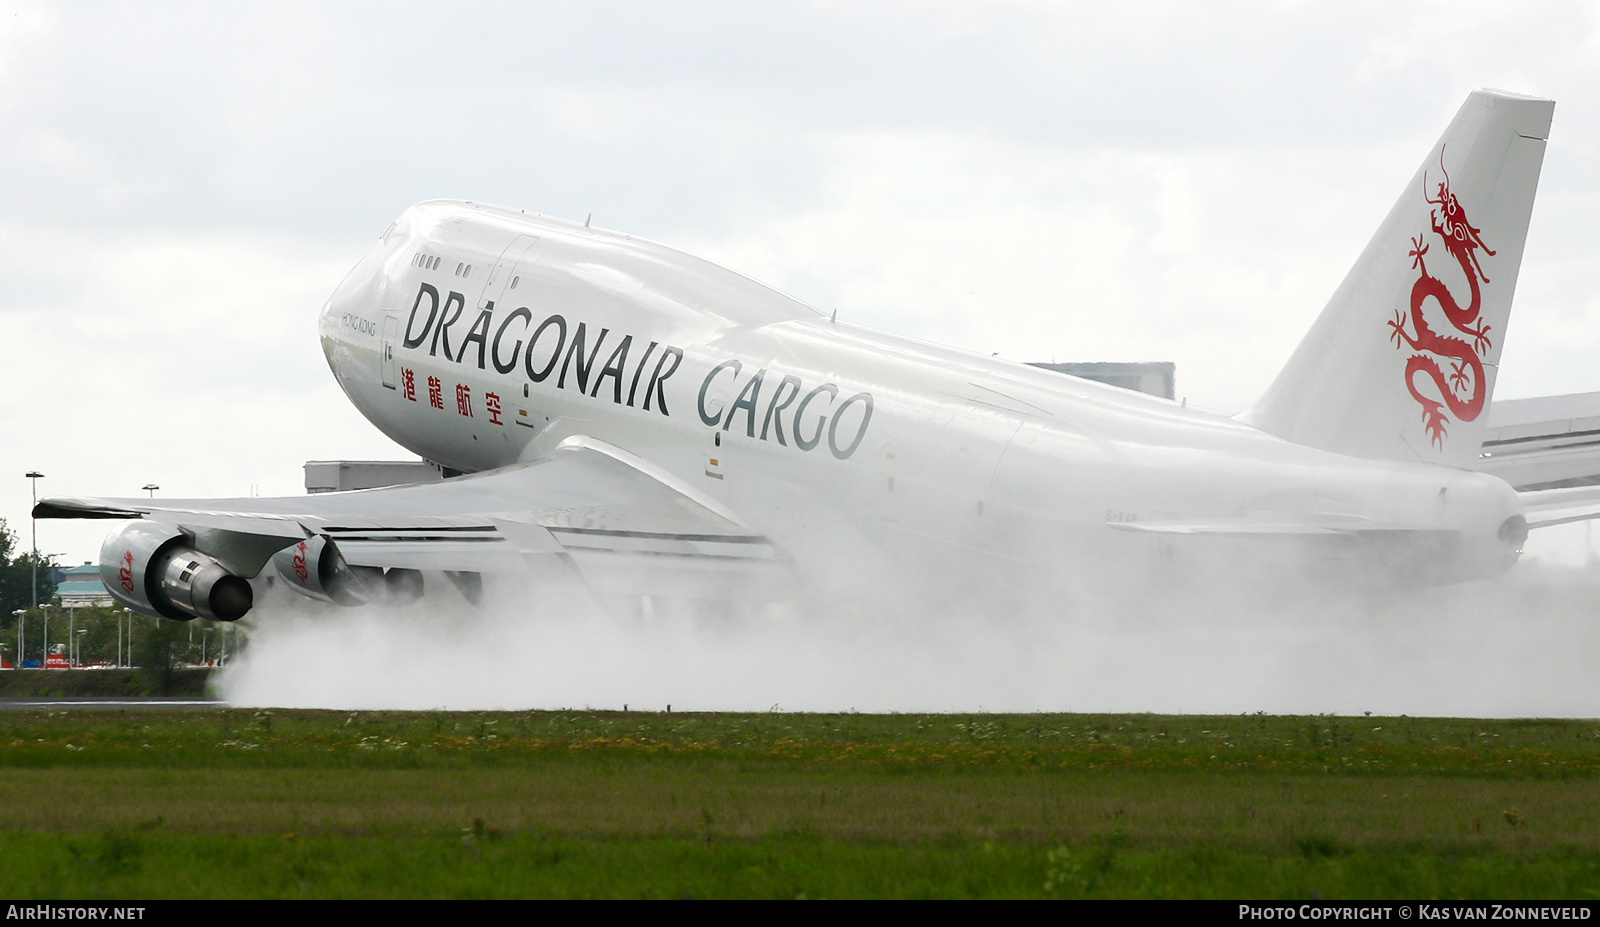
[1389,149,1494,450]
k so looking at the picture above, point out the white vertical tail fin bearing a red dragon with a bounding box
[1240,90,1555,466]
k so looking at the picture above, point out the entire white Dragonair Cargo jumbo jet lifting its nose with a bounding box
[35,91,1600,621]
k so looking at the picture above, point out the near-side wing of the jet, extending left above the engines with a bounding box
[34,437,778,594]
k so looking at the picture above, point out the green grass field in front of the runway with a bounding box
[0,709,1600,898]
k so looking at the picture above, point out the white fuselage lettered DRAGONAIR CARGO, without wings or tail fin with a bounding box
[322,202,1520,595]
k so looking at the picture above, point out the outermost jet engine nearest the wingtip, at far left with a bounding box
[101,520,254,621]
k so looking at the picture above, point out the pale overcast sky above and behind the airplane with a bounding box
[0,0,1600,560]
